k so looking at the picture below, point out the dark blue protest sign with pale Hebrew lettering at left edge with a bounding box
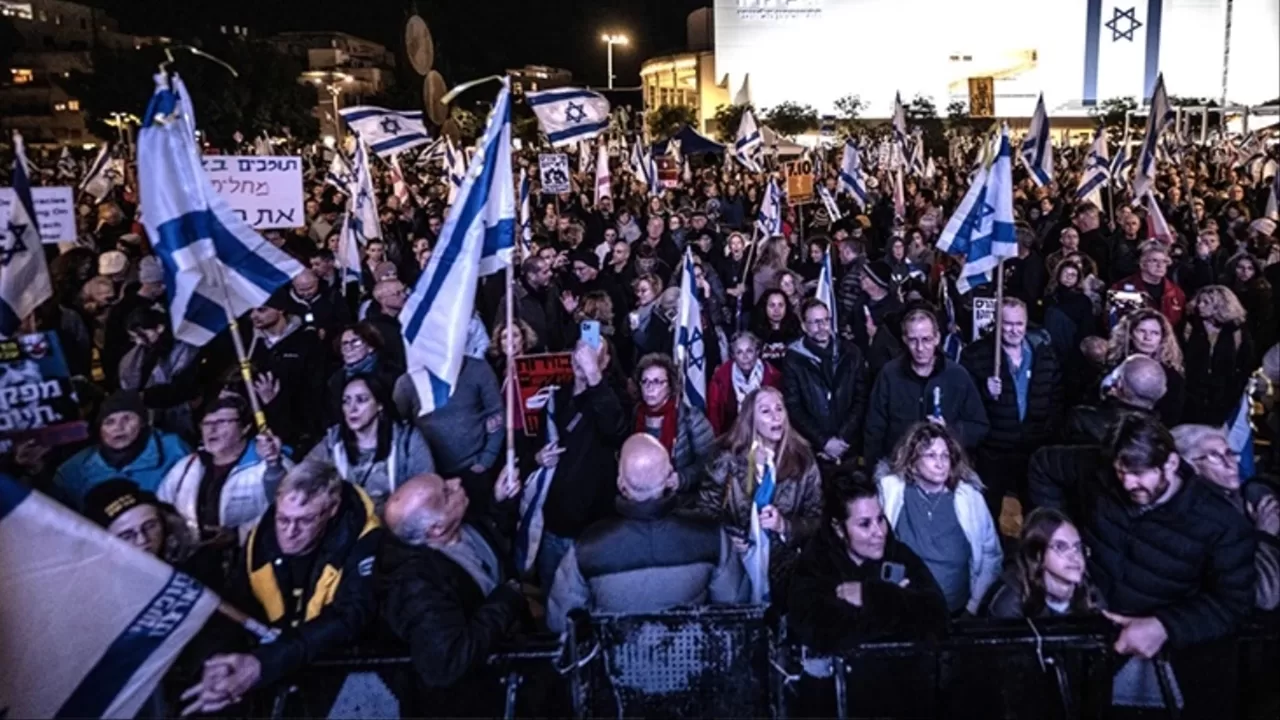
[0,332,88,452]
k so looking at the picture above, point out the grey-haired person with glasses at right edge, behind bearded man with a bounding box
[1172,425,1280,610]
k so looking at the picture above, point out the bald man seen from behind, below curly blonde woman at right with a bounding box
[1065,355,1169,445]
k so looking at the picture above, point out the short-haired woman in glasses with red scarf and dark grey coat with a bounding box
[635,354,716,493]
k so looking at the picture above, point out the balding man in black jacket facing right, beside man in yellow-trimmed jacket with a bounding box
[376,474,527,717]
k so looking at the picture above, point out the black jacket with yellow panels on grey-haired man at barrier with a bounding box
[230,483,383,687]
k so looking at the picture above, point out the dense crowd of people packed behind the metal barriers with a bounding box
[4,116,1280,717]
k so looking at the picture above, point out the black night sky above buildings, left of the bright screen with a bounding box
[81,0,709,87]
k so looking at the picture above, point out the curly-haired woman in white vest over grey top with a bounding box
[876,421,1004,615]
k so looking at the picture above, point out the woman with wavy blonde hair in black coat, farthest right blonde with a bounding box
[1178,284,1257,425]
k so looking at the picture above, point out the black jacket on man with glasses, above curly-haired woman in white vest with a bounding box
[863,356,989,468]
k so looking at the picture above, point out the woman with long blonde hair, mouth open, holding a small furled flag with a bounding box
[698,386,822,597]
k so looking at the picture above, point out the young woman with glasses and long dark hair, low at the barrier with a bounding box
[988,507,1101,618]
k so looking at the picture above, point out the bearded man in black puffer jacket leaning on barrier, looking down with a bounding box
[1028,415,1257,717]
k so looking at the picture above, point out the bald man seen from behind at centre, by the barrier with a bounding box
[547,433,750,632]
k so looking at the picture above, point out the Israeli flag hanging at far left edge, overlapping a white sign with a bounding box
[0,131,54,338]
